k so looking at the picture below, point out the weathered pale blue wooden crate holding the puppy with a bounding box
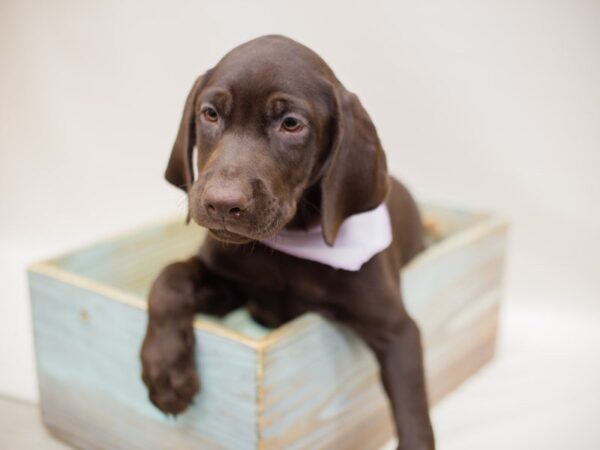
[29,206,507,450]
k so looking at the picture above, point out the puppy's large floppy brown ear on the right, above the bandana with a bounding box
[321,85,389,246]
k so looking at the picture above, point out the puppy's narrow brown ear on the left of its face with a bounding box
[165,72,208,192]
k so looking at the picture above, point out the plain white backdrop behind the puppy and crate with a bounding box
[0,0,600,448]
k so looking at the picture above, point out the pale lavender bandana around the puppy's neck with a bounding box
[261,203,392,272]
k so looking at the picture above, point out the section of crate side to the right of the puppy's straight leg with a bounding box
[402,222,507,404]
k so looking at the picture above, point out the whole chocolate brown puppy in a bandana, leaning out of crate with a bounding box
[141,36,434,450]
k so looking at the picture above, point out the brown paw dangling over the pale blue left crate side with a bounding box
[141,327,200,415]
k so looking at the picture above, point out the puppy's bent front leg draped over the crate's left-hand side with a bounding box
[141,257,240,414]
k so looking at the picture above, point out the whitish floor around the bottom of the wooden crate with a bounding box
[0,300,600,450]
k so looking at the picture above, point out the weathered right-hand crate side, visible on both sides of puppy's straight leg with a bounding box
[259,219,506,449]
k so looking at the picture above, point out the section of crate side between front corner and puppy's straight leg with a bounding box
[259,315,393,450]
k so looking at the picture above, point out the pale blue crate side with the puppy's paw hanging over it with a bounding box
[30,273,256,450]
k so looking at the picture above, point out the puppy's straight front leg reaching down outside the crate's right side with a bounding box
[353,312,435,450]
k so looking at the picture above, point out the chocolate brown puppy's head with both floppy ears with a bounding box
[166,36,388,245]
